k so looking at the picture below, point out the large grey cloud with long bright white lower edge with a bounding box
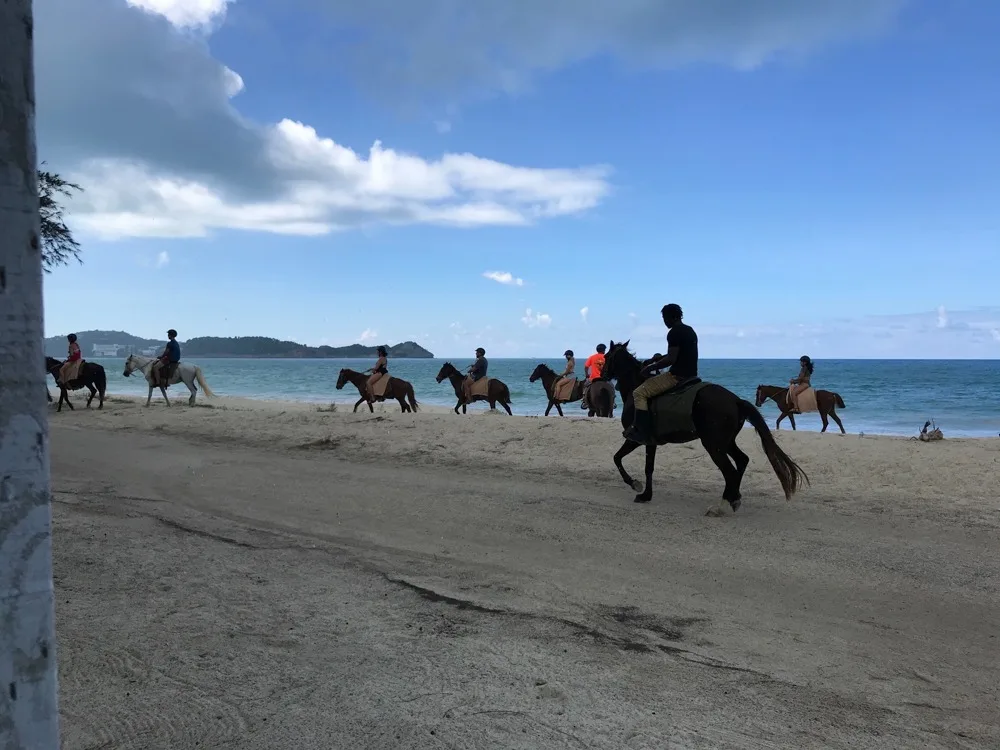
[36,0,610,238]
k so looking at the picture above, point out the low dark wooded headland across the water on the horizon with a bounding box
[45,331,434,359]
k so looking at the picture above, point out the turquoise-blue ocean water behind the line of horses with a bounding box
[82,357,1000,437]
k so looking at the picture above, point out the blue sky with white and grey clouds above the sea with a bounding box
[34,0,1000,360]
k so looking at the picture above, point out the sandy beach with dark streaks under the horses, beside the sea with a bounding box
[50,393,1000,749]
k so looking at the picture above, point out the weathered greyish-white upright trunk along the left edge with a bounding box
[0,0,59,750]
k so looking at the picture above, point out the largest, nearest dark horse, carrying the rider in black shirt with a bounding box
[602,341,809,513]
